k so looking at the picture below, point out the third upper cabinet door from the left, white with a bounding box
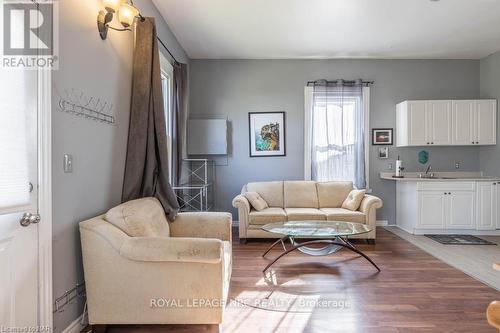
[451,101,475,146]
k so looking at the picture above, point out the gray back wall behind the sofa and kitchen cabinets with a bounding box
[190,60,479,223]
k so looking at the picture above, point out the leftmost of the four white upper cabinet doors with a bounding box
[408,101,430,146]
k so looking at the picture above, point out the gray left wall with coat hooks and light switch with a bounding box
[52,0,189,332]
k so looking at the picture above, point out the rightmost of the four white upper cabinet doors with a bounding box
[475,100,497,145]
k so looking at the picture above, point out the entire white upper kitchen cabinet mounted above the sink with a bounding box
[396,100,497,147]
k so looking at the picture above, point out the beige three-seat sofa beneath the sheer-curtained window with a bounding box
[233,181,382,242]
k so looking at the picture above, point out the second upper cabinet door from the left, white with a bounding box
[427,101,452,145]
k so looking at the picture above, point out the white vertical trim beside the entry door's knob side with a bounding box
[38,60,53,331]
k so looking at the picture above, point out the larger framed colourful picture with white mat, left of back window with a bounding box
[248,112,286,157]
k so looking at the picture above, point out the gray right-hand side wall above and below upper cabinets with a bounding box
[479,52,500,176]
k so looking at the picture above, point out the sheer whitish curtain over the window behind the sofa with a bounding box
[309,80,367,188]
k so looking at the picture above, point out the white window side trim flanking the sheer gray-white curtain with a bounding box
[304,86,371,192]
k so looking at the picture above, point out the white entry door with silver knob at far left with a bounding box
[0,69,38,322]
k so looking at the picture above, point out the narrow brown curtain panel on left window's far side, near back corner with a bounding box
[172,62,188,185]
